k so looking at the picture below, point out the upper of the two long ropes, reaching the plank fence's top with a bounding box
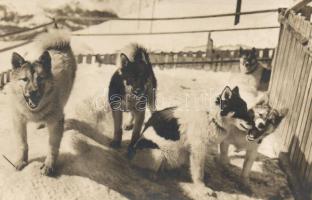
[55,9,278,21]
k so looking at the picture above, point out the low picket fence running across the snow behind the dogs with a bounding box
[77,48,274,72]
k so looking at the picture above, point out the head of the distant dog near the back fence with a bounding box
[239,48,258,74]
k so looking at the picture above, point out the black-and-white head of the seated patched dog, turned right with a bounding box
[216,86,252,131]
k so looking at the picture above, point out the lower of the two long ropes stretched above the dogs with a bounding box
[72,26,280,36]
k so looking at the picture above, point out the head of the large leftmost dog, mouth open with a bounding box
[12,51,52,110]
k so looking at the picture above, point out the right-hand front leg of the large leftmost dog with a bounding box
[41,117,64,176]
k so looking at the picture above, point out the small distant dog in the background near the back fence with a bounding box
[239,48,271,91]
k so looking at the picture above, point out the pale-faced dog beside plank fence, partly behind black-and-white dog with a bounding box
[220,95,288,183]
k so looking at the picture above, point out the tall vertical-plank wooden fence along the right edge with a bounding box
[269,7,312,195]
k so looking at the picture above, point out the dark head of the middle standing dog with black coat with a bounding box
[120,53,150,96]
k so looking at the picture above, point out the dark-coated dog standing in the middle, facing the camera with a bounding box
[109,44,157,153]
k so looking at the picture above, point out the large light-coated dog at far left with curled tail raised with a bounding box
[8,30,76,176]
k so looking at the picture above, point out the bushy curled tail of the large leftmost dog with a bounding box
[36,29,71,51]
